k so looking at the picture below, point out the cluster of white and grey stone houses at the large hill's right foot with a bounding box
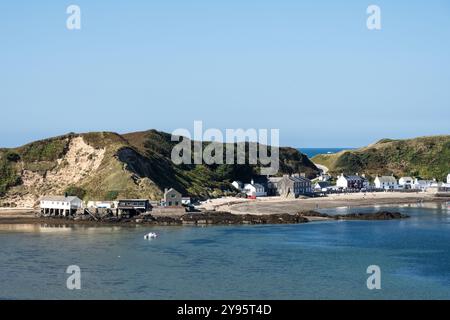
[232,173,313,198]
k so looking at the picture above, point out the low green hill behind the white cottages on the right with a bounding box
[312,135,450,181]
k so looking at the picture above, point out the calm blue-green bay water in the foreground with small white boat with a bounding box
[0,204,450,299]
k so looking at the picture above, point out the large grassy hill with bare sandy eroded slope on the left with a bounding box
[0,130,318,207]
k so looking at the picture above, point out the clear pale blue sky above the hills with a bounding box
[0,0,450,147]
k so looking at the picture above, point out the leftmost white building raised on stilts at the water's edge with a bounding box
[39,196,83,216]
